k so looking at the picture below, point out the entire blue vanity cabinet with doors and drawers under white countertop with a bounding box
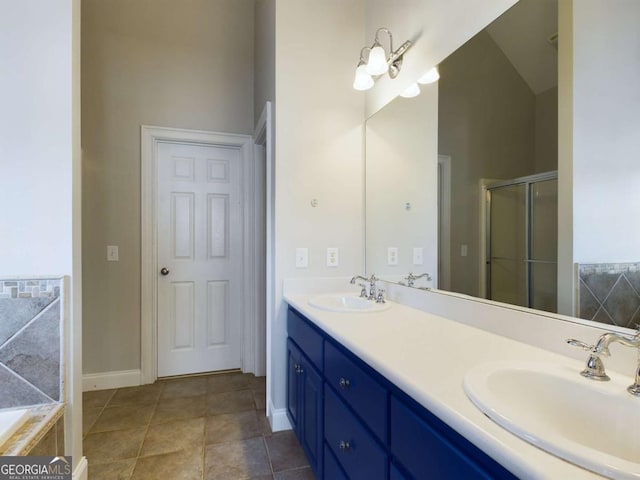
[287,307,516,480]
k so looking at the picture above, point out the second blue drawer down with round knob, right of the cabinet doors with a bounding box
[324,388,387,480]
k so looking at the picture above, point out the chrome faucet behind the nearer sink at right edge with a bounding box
[567,329,640,397]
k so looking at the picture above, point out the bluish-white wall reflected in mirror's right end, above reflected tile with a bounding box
[573,0,640,263]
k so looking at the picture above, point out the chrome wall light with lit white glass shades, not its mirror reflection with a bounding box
[353,28,413,90]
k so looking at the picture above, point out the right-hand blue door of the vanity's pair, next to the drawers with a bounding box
[298,356,323,478]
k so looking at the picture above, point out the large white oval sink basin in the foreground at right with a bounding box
[464,363,640,479]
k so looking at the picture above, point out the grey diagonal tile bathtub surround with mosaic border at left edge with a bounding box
[0,278,62,408]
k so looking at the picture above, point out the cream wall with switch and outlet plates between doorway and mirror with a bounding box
[267,0,364,424]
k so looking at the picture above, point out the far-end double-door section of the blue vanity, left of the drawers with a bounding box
[287,312,324,478]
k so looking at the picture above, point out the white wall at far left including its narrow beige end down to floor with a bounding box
[0,0,82,468]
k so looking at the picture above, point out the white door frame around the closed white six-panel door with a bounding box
[140,125,258,384]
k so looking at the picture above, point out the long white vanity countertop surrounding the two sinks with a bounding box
[285,292,603,480]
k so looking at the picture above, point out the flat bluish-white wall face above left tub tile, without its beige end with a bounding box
[0,0,73,277]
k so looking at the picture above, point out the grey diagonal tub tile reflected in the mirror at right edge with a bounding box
[578,263,640,328]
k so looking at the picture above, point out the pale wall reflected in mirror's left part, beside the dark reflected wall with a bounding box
[365,84,438,286]
